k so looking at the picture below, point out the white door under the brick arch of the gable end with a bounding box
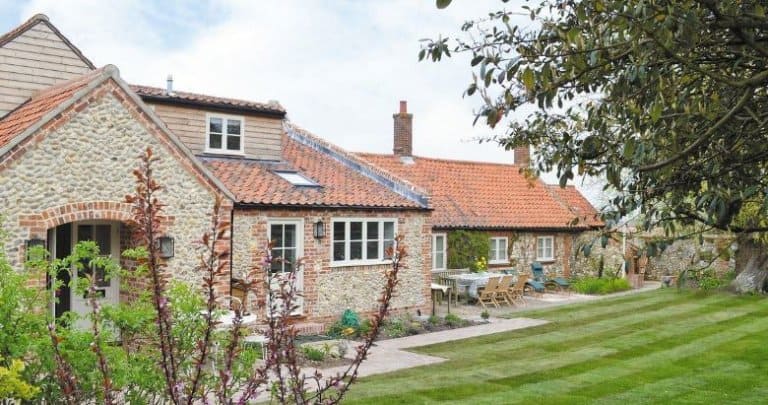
[70,222,120,328]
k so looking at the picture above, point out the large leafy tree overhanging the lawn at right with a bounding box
[426,0,768,291]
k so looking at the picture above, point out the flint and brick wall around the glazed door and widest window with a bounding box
[232,208,431,324]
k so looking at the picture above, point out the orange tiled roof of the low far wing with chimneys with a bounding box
[358,153,596,229]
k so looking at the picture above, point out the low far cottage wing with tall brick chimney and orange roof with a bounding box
[357,101,602,277]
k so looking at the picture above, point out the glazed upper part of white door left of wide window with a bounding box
[267,219,304,273]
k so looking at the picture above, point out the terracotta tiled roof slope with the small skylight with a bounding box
[201,135,423,209]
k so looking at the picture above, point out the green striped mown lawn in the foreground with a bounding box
[345,289,768,404]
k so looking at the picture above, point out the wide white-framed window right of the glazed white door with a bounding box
[331,218,397,266]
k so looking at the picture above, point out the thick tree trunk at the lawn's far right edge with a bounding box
[731,235,768,293]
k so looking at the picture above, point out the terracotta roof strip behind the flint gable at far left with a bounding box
[0,68,104,147]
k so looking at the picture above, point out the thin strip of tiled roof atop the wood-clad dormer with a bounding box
[131,84,285,115]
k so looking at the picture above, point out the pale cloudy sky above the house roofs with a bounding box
[0,0,608,205]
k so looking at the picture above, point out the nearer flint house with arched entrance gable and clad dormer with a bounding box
[0,15,432,328]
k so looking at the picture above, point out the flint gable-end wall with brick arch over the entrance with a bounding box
[0,81,232,291]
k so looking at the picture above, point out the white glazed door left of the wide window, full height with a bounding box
[267,219,304,315]
